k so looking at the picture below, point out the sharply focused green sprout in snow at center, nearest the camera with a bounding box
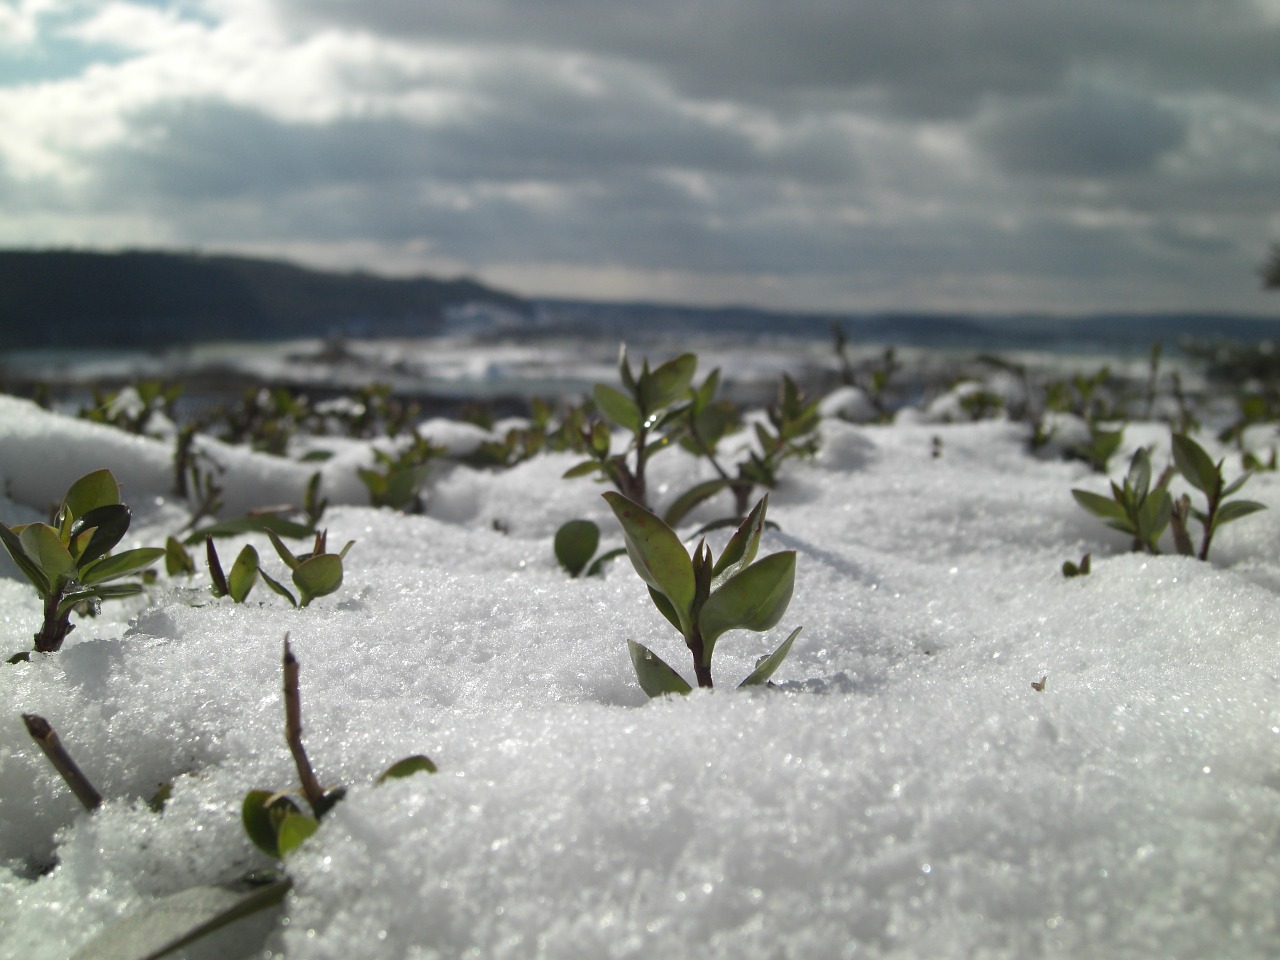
[604,492,800,696]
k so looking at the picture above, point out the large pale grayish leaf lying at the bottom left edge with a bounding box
[70,877,293,960]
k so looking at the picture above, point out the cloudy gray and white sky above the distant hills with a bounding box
[0,0,1280,315]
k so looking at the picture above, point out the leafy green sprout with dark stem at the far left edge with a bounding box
[0,470,165,653]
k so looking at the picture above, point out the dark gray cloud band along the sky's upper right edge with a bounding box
[276,0,1280,116]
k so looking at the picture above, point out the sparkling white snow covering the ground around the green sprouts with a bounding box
[0,378,1280,960]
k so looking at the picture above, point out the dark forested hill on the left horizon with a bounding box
[0,251,529,349]
